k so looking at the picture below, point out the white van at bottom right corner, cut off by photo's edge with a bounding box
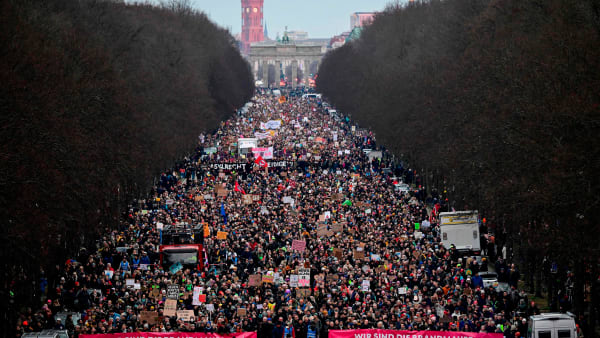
[527,313,577,338]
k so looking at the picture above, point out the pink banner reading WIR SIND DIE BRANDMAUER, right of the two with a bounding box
[329,330,503,338]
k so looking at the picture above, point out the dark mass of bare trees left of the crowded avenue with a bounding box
[0,0,254,333]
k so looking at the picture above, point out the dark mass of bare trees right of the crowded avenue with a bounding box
[317,0,600,324]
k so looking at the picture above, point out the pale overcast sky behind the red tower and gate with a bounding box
[191,0,405,39]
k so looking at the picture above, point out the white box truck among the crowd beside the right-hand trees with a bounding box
[440,210,481,255]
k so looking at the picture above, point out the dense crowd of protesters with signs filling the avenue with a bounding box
[17,95,539,338]
